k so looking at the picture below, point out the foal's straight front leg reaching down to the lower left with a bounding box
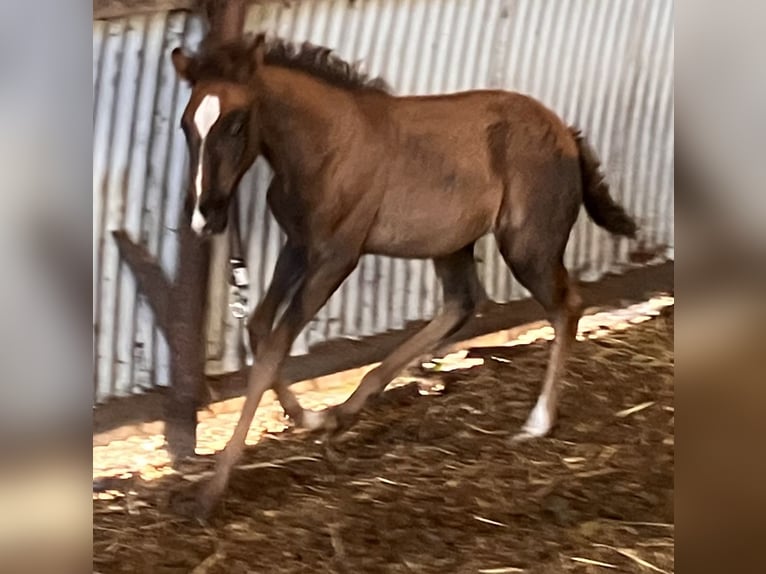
[198,251,359,517]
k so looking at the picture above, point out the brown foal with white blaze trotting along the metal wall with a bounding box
[172,36,636,515]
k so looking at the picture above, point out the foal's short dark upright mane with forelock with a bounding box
[190,34,391,93]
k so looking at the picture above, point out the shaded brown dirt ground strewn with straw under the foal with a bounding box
[93,307,674,574]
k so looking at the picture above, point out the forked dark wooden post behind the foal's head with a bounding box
[114,0,246,462]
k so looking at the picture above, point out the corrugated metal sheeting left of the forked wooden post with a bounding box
[93,13,202,400]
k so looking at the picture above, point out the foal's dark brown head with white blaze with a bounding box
[172,38,263,235]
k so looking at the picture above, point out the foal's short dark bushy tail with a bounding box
[569,128,638,239]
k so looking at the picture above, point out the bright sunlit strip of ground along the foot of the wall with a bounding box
[93,296,674,490]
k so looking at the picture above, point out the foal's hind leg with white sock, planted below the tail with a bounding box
[496,220,582,440]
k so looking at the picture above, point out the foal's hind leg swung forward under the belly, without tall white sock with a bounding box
[316,244,483,432]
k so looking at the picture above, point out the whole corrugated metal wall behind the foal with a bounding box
[93,0,673,399]
